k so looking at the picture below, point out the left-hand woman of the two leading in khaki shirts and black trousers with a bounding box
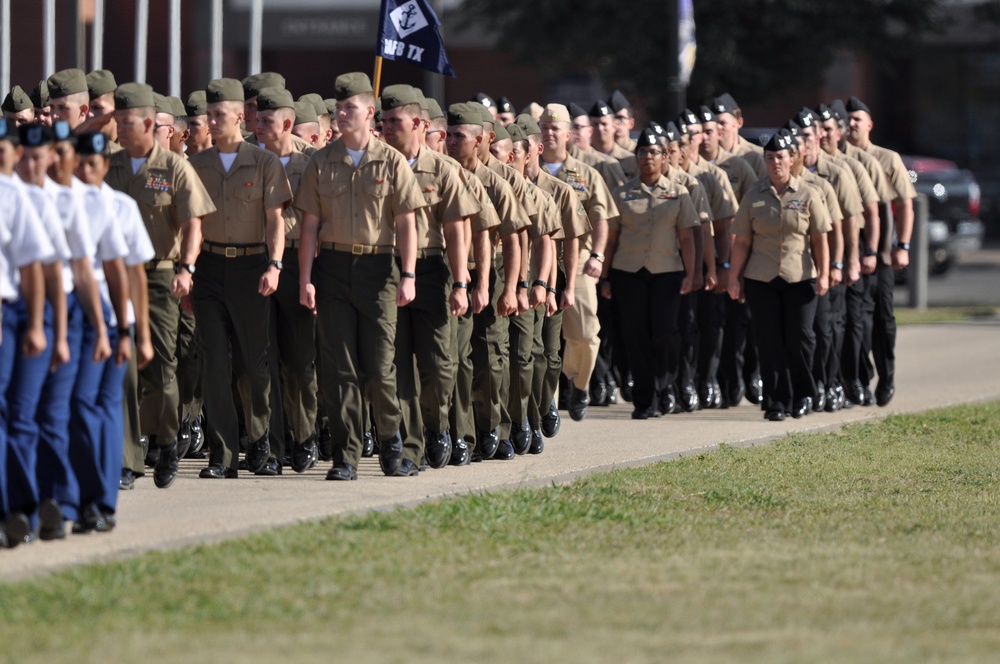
[602,129,700,420]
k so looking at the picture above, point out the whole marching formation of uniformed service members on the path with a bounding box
[0,63,915,547]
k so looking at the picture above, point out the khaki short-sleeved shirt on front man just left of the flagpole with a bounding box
[295,138,425,247]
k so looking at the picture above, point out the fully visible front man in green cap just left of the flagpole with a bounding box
[295,73,426,480]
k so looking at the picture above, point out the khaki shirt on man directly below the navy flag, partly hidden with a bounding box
[412,148,482,249]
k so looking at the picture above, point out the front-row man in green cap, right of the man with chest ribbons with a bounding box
[189,78,292,479]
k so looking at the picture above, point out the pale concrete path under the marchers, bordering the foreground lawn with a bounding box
[0,321,1000,580]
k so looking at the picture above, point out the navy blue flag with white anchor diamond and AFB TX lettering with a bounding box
[378,0,455,76]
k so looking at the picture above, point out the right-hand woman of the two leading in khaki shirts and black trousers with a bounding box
[729,129,832,421]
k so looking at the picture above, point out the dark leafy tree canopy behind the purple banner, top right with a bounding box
[462,0,943,117]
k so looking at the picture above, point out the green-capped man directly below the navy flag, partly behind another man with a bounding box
[381,85,481,468]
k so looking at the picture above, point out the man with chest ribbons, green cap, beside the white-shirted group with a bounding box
[105,83,215,488]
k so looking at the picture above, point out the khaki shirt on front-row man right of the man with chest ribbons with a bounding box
[188,141,292,244]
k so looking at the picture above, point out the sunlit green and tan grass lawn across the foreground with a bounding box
[0,404,1000,664]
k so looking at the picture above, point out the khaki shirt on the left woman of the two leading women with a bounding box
[608,175,701,274]
